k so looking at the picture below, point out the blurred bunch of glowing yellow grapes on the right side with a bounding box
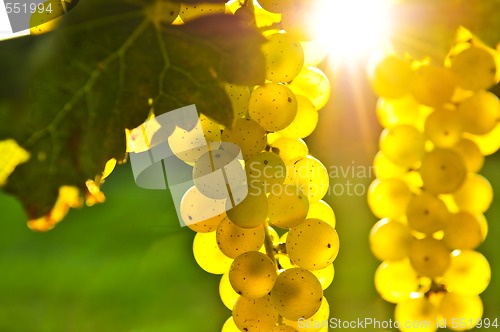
[368,32,500,331]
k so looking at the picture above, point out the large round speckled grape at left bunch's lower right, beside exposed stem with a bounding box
[286,219,339,270]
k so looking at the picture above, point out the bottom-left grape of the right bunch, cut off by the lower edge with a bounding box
[394,297,438,332]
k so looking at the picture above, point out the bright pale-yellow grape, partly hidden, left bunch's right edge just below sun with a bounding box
[288,67,331,110]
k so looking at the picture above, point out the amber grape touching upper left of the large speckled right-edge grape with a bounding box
[268,184,309,228]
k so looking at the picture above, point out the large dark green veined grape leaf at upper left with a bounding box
[0,0,265,223]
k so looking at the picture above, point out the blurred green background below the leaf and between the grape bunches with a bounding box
[0,62,500,332]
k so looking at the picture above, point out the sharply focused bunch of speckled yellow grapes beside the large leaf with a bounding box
[169,0,339,332]
